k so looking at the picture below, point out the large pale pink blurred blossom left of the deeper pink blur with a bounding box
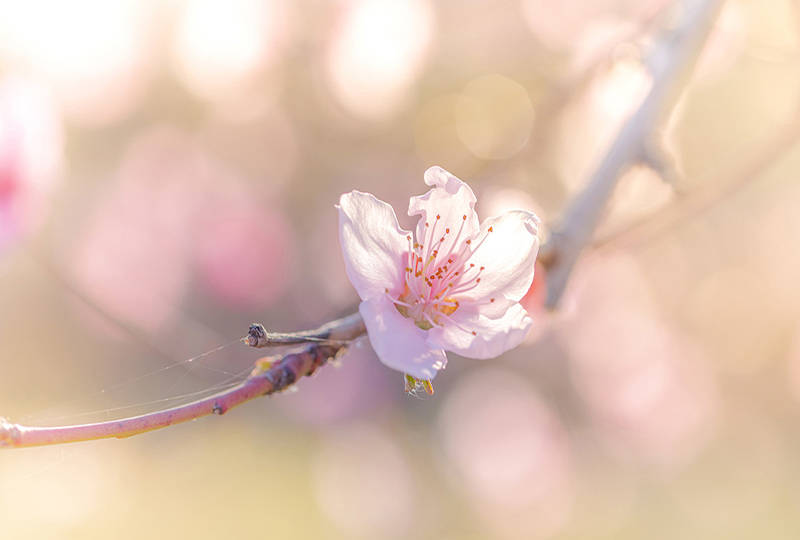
[69,128,200,331]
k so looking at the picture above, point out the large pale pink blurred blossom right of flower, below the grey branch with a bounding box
[561,255,717,465]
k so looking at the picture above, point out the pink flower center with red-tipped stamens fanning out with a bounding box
[387,214,494,334]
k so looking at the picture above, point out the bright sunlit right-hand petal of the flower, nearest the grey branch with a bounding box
[450,210,539,302]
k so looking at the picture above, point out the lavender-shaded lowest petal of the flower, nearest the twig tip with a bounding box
[358,296,447,380]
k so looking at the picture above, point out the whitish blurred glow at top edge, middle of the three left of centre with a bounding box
[174,0,285,99]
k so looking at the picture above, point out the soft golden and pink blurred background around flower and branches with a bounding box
[0,0,800,539]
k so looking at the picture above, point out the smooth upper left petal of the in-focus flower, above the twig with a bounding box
[337,191,409,300]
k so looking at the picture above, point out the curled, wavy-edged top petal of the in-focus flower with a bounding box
[408,167,480,264]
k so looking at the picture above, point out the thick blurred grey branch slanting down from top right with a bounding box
[542,0,719,308]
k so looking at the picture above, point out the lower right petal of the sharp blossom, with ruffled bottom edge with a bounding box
[428,300,533,358]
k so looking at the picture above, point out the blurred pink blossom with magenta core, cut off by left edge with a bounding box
[0,77,63,250]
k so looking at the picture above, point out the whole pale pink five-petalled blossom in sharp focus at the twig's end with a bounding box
[337,167,539,382]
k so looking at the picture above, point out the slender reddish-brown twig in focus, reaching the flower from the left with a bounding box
[0,313,366,448]
